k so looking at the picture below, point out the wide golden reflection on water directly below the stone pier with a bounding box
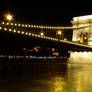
[67,64,92,92]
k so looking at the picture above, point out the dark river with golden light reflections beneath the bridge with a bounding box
[0,61,92,92]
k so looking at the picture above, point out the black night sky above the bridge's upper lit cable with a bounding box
[0,0,92,26]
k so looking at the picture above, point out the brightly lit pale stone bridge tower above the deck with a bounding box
[71,15,92,45]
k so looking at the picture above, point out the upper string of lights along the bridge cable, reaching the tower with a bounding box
[1,22,90,30]
